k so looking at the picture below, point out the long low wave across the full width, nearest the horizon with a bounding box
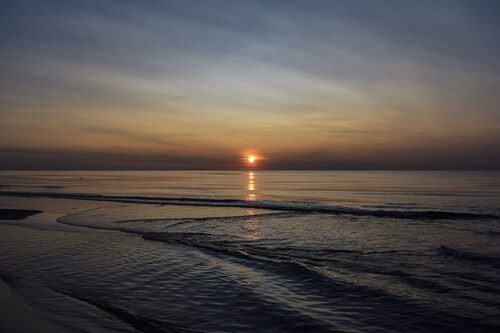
[0,191,500,220]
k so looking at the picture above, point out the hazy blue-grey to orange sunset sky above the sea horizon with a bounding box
[0,0,500,170]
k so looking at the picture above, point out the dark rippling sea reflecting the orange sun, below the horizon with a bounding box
[0,171,500,332]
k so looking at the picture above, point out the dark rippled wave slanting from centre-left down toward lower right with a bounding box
[142,232,462,294]
